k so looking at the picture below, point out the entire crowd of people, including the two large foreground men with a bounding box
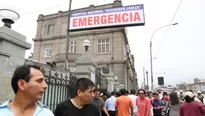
[0,65,205,116]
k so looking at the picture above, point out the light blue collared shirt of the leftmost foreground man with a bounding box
[0,100,54,116]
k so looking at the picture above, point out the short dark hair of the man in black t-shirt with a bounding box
[75,78,95,96]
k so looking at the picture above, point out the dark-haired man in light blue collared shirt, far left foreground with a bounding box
[0,65,54,116]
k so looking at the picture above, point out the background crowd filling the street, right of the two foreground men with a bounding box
[94,89,205,116]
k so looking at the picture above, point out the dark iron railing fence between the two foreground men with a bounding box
[41,71,77,111]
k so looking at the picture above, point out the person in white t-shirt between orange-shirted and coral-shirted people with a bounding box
[128,89,137,116]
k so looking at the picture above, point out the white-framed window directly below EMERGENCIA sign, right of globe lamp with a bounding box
[98,38,110,53]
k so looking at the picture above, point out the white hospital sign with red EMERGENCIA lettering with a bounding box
[70,4,145,31]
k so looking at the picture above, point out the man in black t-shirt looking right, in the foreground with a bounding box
[54,78,100,116]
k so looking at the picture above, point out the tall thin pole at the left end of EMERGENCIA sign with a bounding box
[65,0,72,70]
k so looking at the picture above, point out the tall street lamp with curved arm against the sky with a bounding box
[150,23,178,90]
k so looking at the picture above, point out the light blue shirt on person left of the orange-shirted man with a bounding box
[105,96,116,111]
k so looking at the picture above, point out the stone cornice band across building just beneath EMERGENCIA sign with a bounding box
[33,28,123,42]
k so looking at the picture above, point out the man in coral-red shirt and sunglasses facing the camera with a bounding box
[136,89,152,116]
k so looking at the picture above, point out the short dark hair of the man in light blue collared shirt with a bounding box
[11,65,41,94]
